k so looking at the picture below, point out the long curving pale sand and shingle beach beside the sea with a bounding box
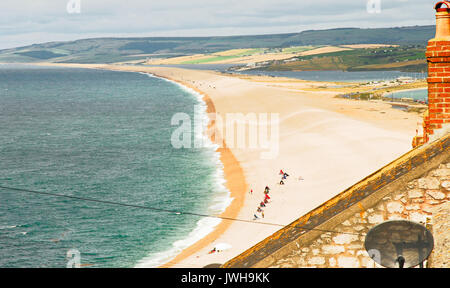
[29,64,420,267]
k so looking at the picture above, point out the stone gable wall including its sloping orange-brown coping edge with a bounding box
[221,133,450,268]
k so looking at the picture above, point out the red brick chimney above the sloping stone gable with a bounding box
[413,1,450,147]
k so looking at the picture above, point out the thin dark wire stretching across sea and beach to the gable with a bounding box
[0,185,366,236]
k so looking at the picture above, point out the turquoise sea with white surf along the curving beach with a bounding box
[0,65,229,267]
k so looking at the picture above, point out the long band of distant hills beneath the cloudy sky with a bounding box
[0,26,435,63]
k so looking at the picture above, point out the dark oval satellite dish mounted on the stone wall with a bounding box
[364,220,434,268]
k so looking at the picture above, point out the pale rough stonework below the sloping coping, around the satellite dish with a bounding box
[271,162,450,268]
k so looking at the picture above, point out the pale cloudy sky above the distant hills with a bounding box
[0,0,438,49]
